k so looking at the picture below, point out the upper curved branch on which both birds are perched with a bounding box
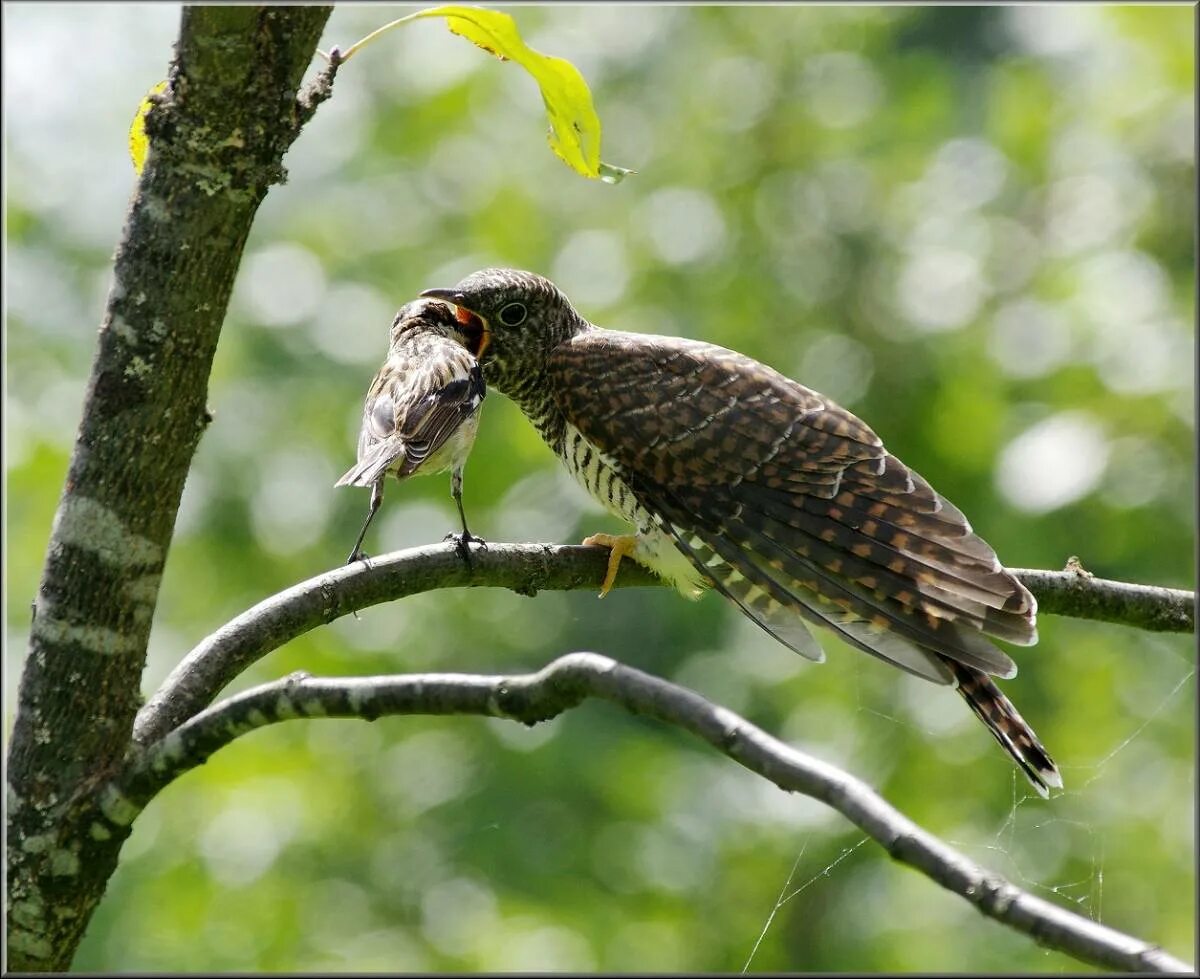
[133,543,1195,744]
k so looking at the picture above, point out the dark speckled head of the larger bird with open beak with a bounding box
[421,269,588,391]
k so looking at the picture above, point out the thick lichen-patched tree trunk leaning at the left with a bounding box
[6,6,331,971]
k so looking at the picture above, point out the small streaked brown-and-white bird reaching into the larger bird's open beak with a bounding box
[335,299,486,564]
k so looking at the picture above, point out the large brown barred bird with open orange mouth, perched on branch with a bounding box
[421,269,1062,797]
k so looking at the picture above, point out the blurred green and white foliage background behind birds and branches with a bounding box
[4,4,1196,972]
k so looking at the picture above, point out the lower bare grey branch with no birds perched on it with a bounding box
[114,652,1193,973]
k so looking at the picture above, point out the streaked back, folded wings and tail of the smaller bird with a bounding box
[336,338,486,486]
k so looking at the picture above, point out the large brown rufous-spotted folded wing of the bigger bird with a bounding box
[547,330,1037,683]
